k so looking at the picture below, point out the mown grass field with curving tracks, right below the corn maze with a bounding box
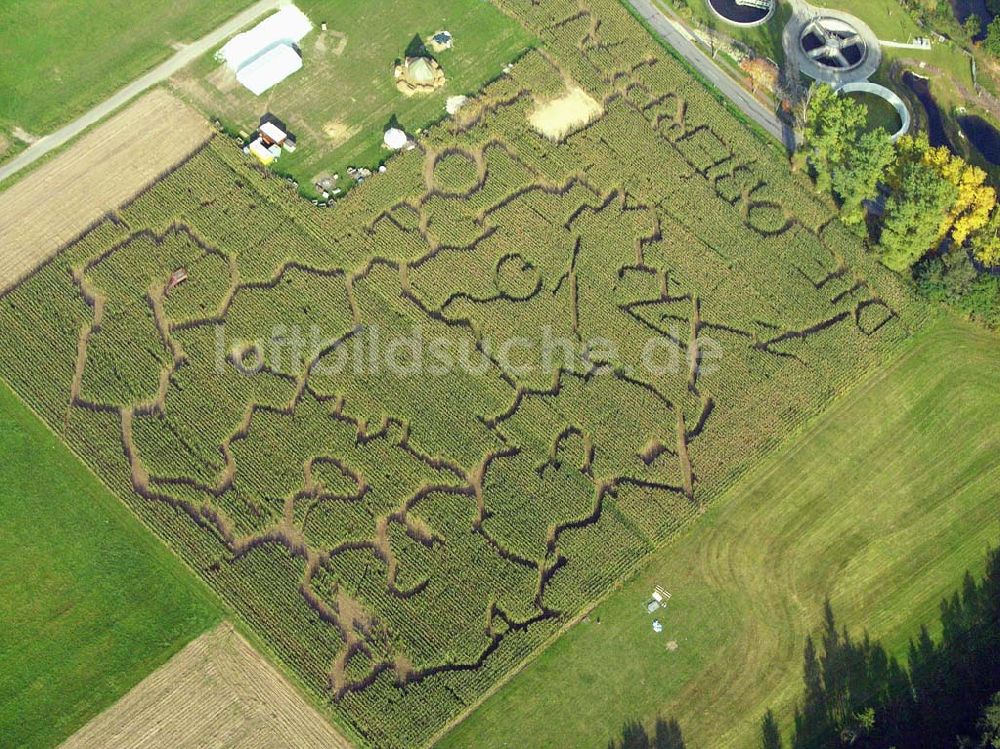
[439,320,1000,749]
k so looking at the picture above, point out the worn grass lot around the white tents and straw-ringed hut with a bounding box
[174,0,532,195]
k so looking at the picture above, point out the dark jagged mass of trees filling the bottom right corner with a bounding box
[761,549,1000,749]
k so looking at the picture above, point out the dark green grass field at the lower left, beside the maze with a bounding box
[0,383,220,747]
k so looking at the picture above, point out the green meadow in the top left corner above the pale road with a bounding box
[0,0,251,140]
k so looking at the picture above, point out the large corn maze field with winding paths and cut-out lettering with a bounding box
[0,0,922,747]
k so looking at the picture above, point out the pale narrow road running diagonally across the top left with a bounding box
[0,0,288,181]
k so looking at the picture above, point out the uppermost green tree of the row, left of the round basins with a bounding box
[802,84,868,190]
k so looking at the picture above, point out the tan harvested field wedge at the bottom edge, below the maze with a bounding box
[62,622,351,749]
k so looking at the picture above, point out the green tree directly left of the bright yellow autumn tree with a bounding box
[881,159,958,271]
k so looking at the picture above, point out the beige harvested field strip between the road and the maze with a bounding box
[0,90,212,289]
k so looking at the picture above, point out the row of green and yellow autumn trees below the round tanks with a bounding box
[784,82,1000,327]
